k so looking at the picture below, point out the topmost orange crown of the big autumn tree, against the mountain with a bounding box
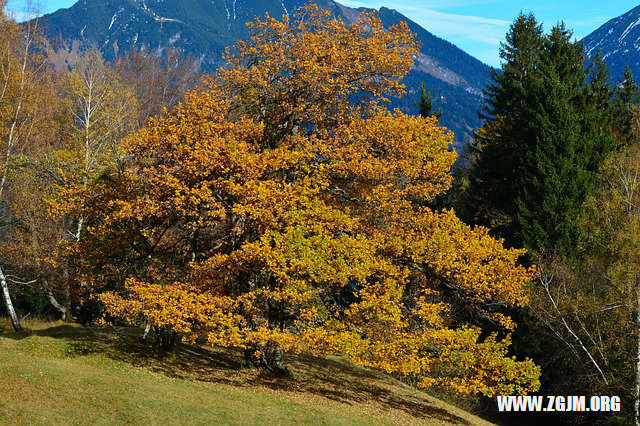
[209,6,417,143]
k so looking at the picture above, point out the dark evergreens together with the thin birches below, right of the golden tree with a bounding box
[453,15,640,421]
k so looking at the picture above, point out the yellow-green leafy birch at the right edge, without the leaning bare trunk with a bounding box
[585,139,640,425]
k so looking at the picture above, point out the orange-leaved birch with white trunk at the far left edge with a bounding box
[0,0,55,331]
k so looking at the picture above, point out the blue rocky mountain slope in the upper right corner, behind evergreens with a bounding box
[584,6,640,80]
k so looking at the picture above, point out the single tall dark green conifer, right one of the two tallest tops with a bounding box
[514,24,590,253]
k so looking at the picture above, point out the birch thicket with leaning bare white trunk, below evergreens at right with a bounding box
[530,120,640,425]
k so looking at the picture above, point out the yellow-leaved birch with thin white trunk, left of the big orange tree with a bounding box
[44,48,137,316]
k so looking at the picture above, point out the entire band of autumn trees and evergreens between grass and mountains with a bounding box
[0,0,640,424]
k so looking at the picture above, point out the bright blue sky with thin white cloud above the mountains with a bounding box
[9,0,640,66]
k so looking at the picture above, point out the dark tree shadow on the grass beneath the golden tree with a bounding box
[2,325,469,424]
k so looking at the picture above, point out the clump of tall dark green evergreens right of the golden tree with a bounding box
[463,15,616,255]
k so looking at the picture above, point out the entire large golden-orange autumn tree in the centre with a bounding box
[66,5,539,395]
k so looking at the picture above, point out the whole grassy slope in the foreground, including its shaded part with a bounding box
[0,324,484,425]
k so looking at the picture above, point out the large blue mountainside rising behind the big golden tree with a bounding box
[36,0,490,146]
